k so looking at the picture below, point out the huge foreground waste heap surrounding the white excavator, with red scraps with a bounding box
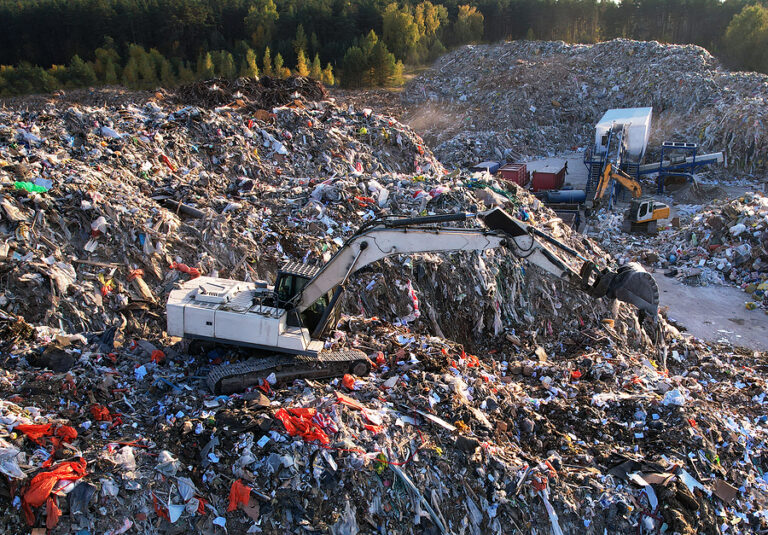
[0,76,768,535]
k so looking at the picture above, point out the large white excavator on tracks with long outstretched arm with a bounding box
[166,208,659,394]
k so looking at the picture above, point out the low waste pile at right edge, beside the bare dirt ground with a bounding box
[590,192,768,310]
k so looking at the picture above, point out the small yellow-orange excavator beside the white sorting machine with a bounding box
[595,162,669,234]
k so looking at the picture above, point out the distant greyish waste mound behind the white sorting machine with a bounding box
[402,39,768,171]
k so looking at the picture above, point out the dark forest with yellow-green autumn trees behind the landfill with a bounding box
[0,0,768,96]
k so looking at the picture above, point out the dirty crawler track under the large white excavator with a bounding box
[206,349,371,394]
